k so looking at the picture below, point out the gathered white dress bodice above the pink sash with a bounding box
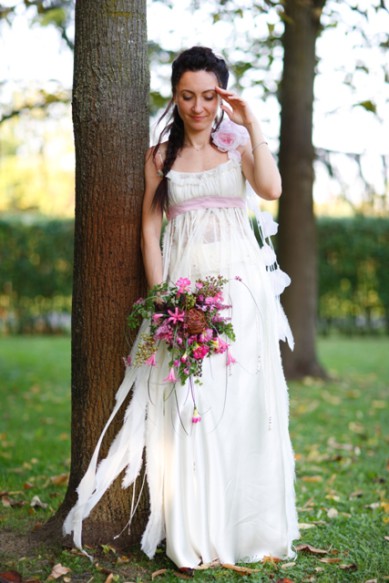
[167,159,245,205]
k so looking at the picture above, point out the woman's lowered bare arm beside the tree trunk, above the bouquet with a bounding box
[141,149,163,287]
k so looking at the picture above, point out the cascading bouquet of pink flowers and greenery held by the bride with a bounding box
[127,275,235,422]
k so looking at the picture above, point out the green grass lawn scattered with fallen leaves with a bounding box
[0,337,389,583]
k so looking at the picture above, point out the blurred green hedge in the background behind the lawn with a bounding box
[0,217,389,334]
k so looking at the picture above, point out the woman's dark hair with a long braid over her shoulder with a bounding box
[153,46,229,211]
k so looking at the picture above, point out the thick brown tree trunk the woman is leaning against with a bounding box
[37,0,149,544]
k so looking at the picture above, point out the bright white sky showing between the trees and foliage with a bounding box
[0,0,389,210]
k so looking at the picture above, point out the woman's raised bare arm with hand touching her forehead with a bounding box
[217,87,282,200]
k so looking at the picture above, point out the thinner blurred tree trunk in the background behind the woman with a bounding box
[278,0,325,379]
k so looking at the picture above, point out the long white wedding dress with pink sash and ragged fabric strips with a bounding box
[64,156,298,567]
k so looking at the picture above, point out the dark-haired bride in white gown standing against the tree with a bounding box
[64,47,298,568]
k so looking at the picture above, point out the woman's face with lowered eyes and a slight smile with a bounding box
[174,71,220,131]
